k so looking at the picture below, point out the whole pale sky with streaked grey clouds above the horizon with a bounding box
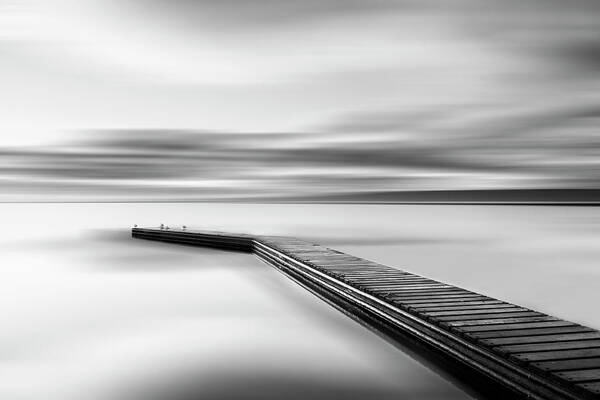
[0,0,600,200]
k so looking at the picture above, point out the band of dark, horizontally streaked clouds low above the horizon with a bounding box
[0,98,600,200]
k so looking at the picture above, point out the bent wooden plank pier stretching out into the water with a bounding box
[132,228,600,399]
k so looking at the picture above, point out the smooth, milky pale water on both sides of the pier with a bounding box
[0,204,600,400]
